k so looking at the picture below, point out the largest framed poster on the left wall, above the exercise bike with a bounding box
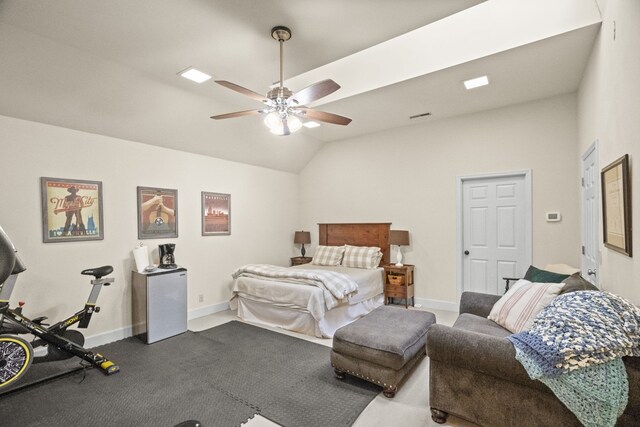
[40,177,104,243]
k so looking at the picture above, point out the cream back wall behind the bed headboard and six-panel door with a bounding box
[300,95,580,306]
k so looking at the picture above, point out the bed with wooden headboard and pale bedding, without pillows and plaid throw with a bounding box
[230,223,390,338]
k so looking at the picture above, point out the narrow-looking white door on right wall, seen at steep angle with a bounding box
[582,142,600,286]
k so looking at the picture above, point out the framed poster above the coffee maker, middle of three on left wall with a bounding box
[138,187,178,239]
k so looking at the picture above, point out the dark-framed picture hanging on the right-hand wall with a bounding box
[600,154,632,257]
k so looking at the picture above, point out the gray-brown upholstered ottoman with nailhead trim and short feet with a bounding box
[331,305,436,398]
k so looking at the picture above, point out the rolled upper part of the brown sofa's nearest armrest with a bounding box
[427,324,546,389]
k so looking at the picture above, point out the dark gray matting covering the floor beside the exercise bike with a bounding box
[0,321,380,427]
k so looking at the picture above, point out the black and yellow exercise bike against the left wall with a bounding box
[0,227,120,391]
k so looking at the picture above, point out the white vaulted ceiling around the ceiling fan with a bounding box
[0,0,600,172]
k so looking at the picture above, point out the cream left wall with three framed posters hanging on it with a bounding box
[0,116,298,342]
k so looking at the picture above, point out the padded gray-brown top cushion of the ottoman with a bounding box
[333,306,436,369]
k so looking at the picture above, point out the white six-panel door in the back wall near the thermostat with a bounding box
[460,172,531,295]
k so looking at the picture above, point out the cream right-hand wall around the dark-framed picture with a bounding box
[578,0,640,304]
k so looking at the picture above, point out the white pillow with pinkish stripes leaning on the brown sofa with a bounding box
[488,279,564,334]
